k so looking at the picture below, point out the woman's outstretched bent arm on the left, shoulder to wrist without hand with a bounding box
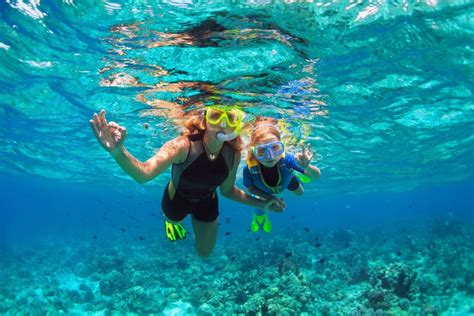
[111,137,189,183]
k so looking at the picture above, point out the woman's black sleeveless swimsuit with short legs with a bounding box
[161,134,235,222]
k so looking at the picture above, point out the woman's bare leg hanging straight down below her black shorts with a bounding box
[192,216,217,258]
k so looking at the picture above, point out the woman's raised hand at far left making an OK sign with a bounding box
[89,110,127,154]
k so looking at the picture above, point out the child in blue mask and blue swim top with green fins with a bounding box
[243,118,321,233]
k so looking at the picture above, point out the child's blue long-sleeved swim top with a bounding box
[244,153,304,194]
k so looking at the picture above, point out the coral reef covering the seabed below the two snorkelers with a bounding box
[0,218,474,315]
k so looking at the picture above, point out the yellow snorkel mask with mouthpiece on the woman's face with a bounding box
[206,105,244,142]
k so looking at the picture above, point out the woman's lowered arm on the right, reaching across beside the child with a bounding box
[220,152,284,212]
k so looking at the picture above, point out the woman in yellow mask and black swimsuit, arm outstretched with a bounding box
[90,106,285,257]
